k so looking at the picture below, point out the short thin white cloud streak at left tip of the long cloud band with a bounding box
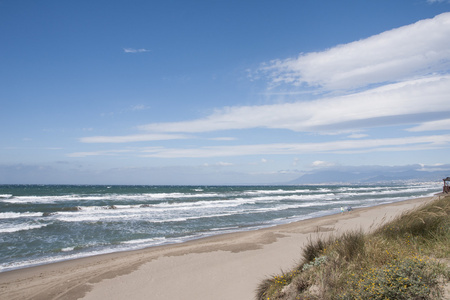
[80,134,189,143]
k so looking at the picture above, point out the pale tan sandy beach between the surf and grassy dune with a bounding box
[0,198,438,300]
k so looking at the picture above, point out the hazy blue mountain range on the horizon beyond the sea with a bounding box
[289,167,450,184]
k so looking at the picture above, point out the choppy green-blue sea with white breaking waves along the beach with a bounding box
[0,182,442,272]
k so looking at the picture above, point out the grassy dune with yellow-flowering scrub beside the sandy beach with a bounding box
[256,197,450,300]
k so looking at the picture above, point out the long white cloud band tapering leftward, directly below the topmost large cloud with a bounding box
[139,75,450,133]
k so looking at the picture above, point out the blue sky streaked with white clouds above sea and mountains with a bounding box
[0,0,450,185]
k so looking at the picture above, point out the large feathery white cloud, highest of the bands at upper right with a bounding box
[260,13,450,89]
